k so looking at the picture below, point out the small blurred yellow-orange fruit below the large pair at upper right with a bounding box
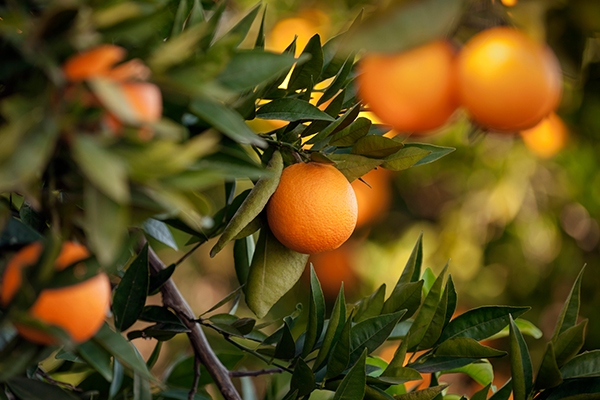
[521,113,568,158]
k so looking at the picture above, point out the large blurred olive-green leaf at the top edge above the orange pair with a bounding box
[344,0,464,52]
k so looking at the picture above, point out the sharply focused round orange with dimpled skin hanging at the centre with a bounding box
[267,162,357,254]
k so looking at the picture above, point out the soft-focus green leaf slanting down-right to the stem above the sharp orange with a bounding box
[190,98,267,148]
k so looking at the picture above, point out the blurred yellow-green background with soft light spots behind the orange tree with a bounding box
[117,0,600,393]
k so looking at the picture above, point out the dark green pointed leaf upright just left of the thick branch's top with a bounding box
[112,243,150,331]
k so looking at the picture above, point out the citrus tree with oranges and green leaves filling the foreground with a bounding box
[0,0,600,400]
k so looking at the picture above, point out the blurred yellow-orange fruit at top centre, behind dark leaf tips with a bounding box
[266,9,330,56]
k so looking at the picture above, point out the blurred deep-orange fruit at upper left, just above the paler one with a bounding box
[63,44,126,82]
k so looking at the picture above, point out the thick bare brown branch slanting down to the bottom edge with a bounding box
[142,239,241,400]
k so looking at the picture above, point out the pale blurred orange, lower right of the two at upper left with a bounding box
[121,82,162,123]
